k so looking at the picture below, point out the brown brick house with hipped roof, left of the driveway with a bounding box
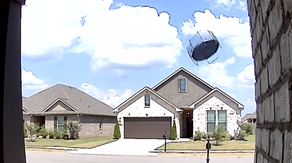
[22,84,117,138]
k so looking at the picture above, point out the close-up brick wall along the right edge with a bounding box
[247,0,292,163]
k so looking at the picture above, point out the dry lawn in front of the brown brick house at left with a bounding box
[25,136,114,148]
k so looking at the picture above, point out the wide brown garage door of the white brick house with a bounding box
[124,117,171,139]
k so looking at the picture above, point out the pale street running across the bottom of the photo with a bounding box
[26,151,253,163]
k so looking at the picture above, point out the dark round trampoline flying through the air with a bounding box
[187,30,220,66]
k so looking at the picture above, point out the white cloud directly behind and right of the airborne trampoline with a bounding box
[181,10,252,57]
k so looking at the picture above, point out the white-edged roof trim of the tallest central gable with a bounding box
[152,67,214,90]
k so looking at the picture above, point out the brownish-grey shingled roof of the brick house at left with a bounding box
[23,84,116,116]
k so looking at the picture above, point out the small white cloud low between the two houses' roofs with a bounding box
[81,83,133,107]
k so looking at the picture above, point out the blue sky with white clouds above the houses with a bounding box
[21,0,255,114]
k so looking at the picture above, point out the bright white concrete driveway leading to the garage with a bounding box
[68,139,164,156]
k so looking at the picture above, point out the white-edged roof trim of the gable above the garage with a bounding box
[114,86,182,112]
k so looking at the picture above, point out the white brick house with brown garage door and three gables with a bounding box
[114,67,244,138]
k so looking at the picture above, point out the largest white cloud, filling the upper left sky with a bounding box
[22,0,182,70]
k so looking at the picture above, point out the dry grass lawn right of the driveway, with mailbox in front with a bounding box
[157,135,255,150]
